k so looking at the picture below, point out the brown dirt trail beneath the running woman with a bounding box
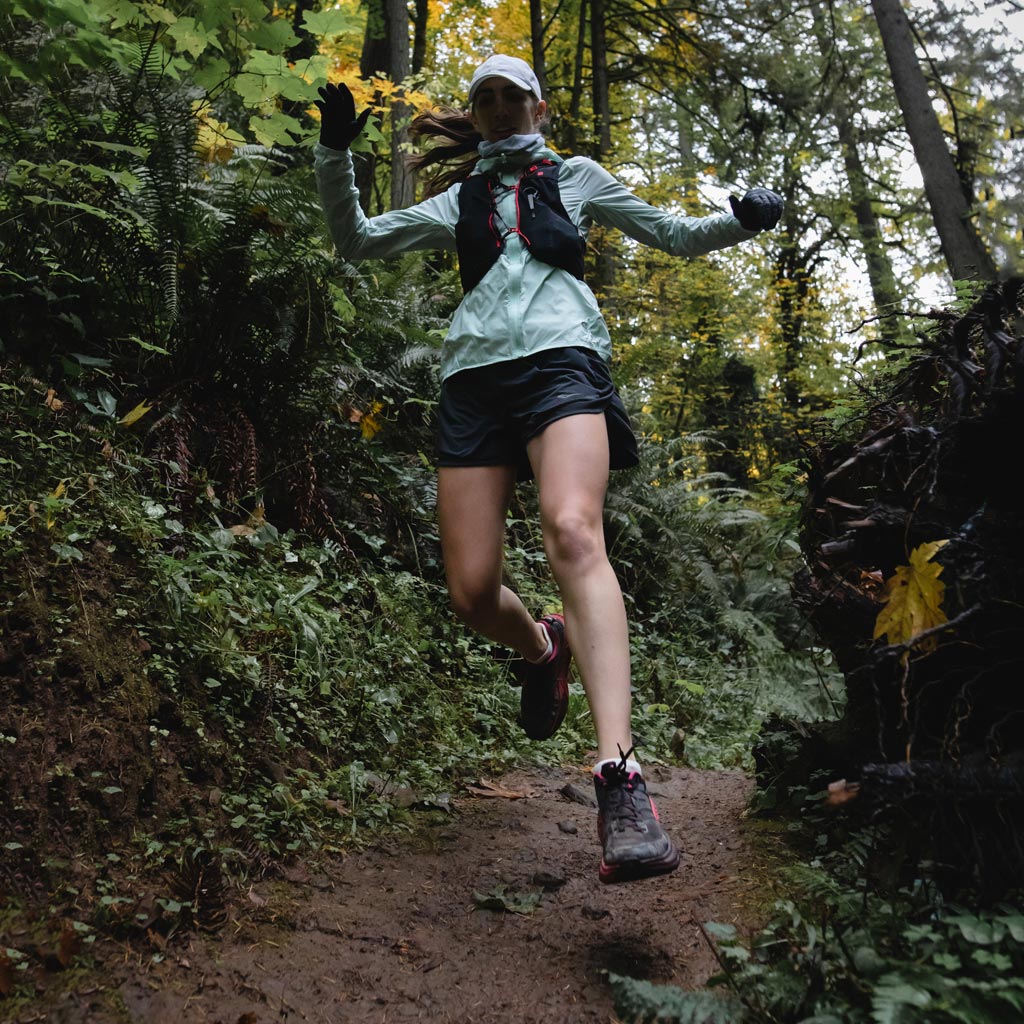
[41,768,750,1024]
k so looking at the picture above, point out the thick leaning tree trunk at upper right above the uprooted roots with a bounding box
[871,0,995,281]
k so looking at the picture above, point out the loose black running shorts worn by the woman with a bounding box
[437,348,639,480]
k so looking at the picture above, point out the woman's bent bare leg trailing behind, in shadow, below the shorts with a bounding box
[437,466,548,660]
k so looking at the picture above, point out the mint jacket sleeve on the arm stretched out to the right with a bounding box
[559,157,758,256]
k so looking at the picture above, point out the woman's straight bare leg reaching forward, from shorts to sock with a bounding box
[527,414,633,760]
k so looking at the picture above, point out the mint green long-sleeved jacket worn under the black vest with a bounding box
[313,143,757,378]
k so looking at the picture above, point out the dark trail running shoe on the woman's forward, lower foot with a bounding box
[594,751,679,883]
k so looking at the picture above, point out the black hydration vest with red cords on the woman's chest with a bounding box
[455,160,586,292]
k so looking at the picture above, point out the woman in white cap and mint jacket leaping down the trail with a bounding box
[314,54,782,882]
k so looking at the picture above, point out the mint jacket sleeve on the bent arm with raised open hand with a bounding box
[313,142,459,259]
